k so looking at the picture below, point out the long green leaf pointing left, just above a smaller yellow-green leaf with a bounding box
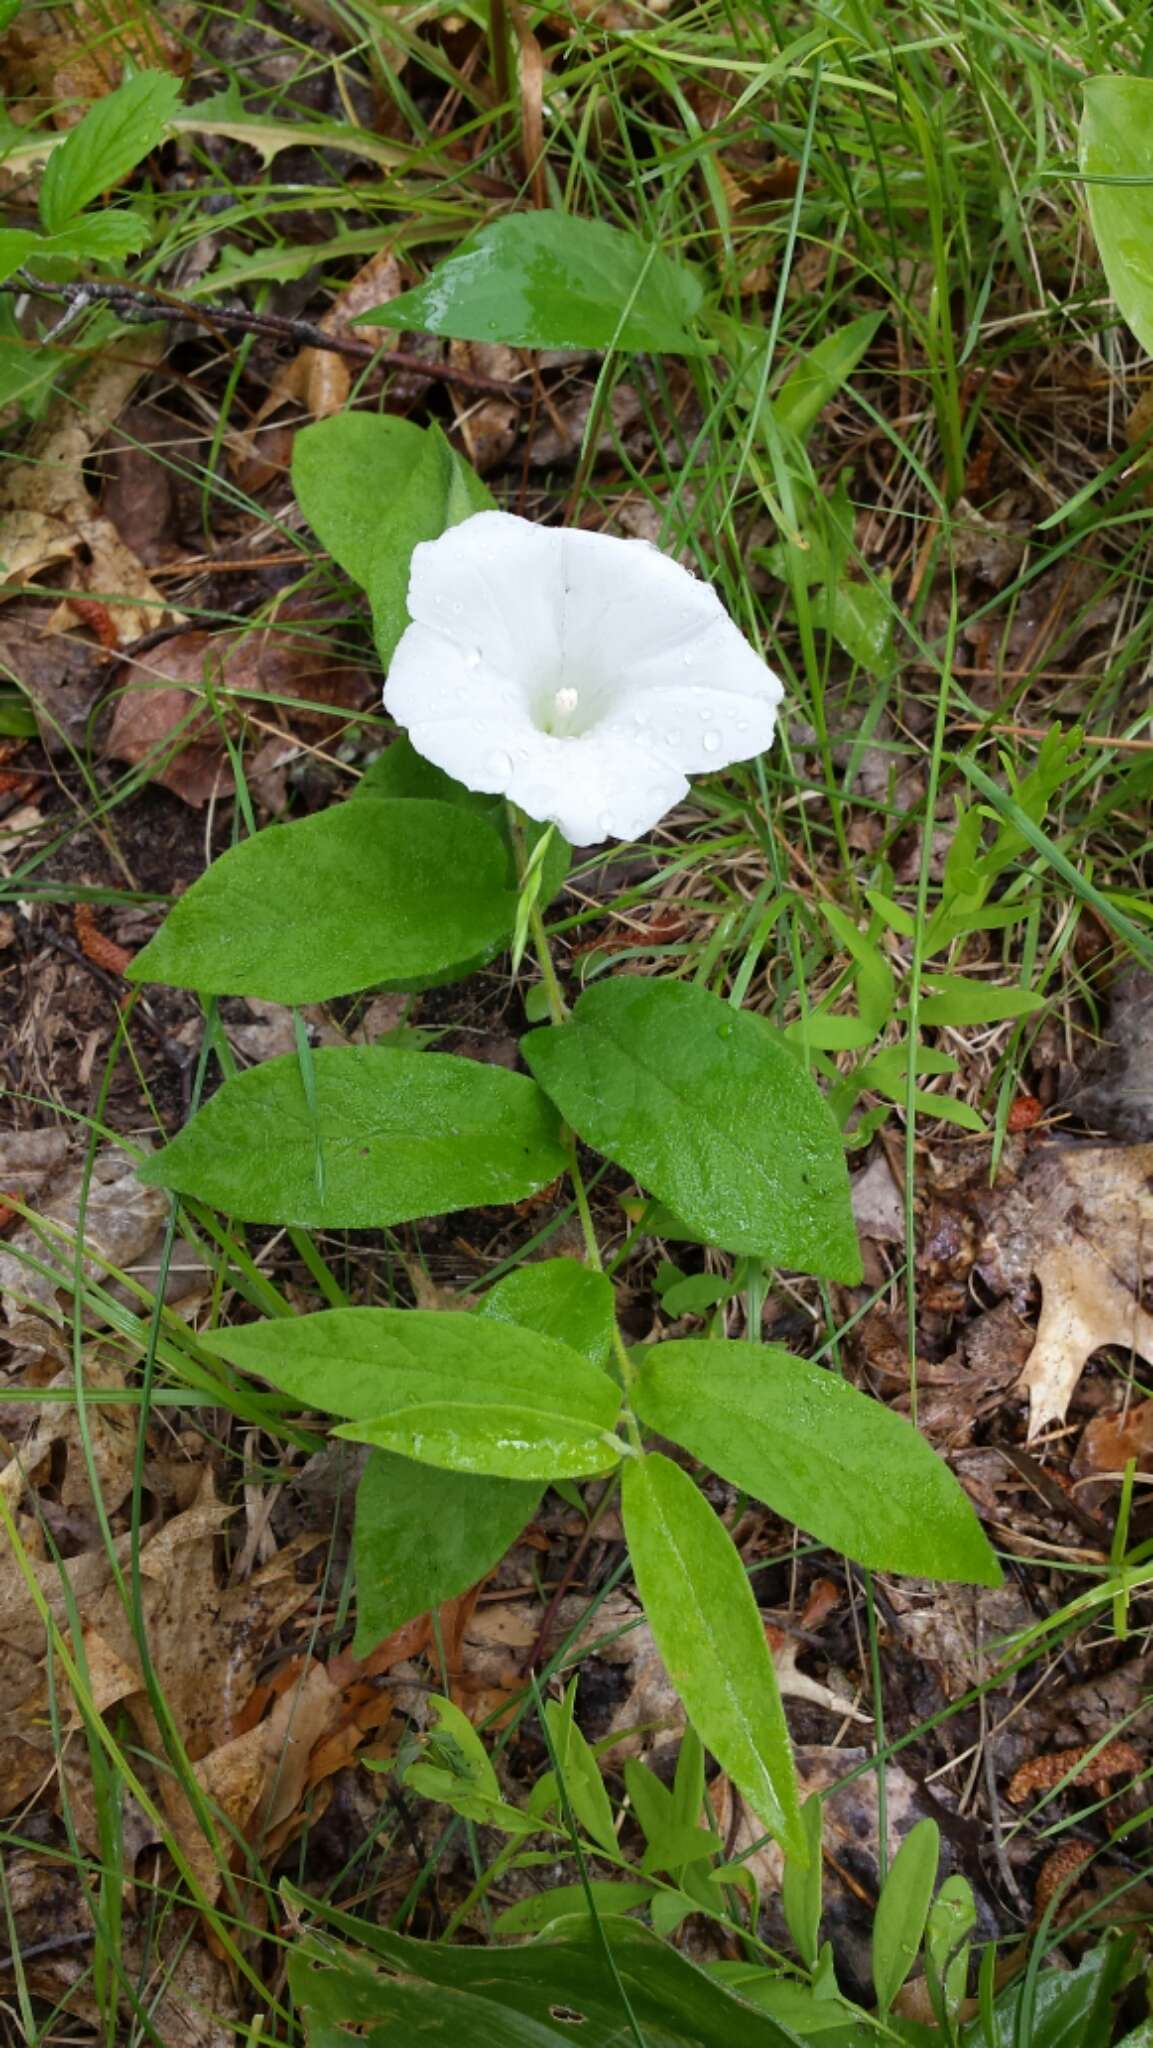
[197,1310,621,1430]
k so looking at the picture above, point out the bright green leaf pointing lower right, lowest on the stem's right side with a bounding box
[633,1337,1001,1585]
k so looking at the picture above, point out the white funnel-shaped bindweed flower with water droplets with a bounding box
[385,512,782,846]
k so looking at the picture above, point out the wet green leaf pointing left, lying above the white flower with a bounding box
[358,209,702,354]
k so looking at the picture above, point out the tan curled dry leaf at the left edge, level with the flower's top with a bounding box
[0,330,168,647]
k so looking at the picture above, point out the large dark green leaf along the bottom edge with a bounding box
[289,1888,797,2048]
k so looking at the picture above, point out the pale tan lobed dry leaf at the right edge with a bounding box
[979,1145,1153,1438]
